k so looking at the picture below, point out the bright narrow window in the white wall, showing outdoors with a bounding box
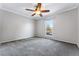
[45,20,54,35]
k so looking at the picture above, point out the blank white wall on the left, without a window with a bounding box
[0,10,34,43]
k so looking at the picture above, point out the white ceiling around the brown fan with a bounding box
[0,3,78,19]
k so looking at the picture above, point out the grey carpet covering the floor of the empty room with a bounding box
[0,38,79,56]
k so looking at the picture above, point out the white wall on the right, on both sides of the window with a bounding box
[37,9,77,43]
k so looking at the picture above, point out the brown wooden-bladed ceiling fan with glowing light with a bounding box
[25,3,50,17]
